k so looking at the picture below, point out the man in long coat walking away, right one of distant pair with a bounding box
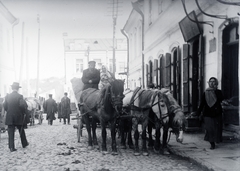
[61,92,72,125]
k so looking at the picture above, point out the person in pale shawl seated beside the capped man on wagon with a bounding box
[99,65,114,89]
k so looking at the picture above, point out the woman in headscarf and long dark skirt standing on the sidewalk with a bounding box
[197,77,223,150]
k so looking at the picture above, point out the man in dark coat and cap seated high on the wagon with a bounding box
[82,61,100,90]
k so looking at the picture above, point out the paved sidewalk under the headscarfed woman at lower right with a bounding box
[168,131,240,171]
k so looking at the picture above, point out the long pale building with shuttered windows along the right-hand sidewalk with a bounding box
[124,0,240,129]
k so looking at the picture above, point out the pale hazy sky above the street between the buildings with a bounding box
[0,0,134,79]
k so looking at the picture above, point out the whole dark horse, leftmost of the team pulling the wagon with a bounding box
[80,79,124,154]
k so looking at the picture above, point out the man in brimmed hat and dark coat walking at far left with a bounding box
[3,82,29,152]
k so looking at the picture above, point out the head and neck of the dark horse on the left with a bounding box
[101,79,124,113]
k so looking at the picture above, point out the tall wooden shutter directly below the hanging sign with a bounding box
[183,44,189,113]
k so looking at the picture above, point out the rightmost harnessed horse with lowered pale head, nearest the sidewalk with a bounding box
[148,88,186,154]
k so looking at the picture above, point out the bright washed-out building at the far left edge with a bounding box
[0,2,18,96]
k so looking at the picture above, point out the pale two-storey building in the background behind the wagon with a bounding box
[64,38,127,101]
